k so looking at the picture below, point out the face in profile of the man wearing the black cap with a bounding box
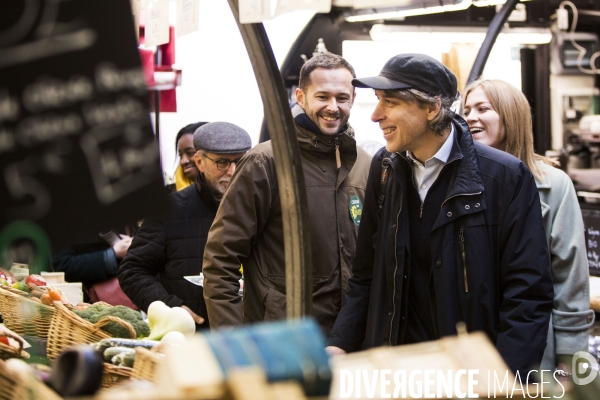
[371,90,443,161]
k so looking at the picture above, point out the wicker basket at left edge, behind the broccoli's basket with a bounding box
[0,286,54,339]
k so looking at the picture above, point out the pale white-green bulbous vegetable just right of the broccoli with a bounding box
[148,301,196,340]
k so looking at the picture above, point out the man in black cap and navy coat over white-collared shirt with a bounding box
[327,54,553,373]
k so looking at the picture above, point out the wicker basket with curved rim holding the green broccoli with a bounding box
[46,302,136,360]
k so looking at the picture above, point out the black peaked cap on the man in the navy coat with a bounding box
[352,53,458,99]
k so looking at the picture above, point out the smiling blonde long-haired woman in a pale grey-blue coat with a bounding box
[463,80,594,370]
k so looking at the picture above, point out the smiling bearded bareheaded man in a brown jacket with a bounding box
[203,53,371,335]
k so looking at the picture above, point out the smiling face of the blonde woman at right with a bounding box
[463,86,506,149]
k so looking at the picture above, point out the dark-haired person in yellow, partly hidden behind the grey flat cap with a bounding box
[175,122,207,191]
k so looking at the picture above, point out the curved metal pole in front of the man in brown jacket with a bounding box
[228,0,312,318]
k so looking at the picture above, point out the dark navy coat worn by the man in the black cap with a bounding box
[329,116,553,371]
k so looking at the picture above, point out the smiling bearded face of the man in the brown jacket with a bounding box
[296,68,356,135]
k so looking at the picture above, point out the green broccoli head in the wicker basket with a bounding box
[73,304,150,339]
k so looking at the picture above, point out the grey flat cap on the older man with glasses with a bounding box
[194,122,252,154]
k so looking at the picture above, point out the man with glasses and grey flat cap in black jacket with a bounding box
[118,122,252,329]
